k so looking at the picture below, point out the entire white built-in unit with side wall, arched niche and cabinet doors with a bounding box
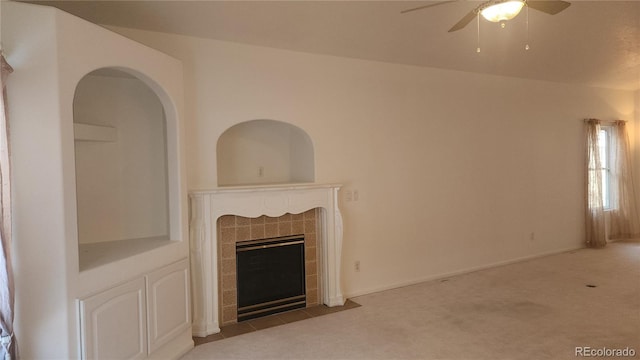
[0,1,193,359]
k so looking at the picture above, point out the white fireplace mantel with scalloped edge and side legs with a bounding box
[189,184,344,337]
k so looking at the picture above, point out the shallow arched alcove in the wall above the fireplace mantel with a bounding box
[217,120,315,186]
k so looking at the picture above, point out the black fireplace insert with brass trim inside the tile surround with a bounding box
[236,235,307,321]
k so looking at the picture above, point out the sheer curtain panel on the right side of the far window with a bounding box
[607,121,640,239]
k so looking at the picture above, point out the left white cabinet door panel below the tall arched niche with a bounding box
[80,278,147,360]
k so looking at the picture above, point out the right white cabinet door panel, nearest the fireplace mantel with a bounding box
[147,260,191,354]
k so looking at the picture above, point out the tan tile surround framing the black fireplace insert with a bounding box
[216,209,319,325]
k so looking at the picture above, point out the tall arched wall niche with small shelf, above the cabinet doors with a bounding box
[73,67,179,258]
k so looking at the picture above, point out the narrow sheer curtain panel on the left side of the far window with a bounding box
[585,119,607,248]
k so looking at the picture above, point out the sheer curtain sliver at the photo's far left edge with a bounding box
[0,49,18,360]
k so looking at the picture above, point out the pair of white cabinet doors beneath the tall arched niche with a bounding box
[79,259,191,360]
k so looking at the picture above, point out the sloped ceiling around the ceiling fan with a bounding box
[20,0,640,90]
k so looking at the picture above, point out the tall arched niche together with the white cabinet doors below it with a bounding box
[73,68,193,359]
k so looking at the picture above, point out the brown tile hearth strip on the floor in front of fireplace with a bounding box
[193,300,360,346]
